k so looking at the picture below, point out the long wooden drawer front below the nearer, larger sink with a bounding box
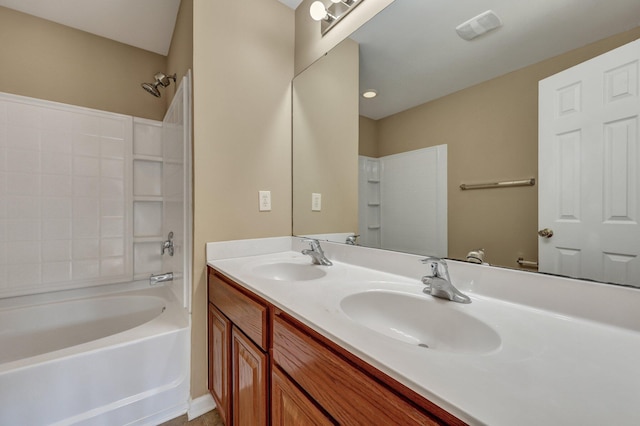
[272,316,442,425]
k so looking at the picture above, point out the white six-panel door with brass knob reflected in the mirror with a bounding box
[538,40,640,286]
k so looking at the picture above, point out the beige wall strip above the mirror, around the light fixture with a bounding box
[295,0,393,75]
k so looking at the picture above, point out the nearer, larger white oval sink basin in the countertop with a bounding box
[340,290,501,354]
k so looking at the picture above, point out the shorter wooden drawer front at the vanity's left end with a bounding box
[209,271,269,352]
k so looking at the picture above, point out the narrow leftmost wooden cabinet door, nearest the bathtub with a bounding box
[209,303,231,423]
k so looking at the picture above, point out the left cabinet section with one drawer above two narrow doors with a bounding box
[208,269,270,426]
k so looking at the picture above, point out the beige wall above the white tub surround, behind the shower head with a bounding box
[0,7,166,120]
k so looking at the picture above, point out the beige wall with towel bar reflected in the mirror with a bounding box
[378,28,640,267]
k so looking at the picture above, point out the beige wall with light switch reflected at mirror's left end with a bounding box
[293,39,359,235]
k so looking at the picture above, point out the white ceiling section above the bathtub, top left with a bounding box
[0,0,180,55]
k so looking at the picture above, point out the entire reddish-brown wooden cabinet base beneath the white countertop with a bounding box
[208,269,465,426]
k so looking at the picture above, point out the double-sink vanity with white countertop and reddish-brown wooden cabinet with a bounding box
[207,237,640,425]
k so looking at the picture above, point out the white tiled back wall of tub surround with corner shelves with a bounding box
[0,94,168,297]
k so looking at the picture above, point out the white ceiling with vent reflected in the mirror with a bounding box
[351,0,640,119]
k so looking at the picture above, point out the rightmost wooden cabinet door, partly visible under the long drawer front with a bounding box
[271,365,337,426]
